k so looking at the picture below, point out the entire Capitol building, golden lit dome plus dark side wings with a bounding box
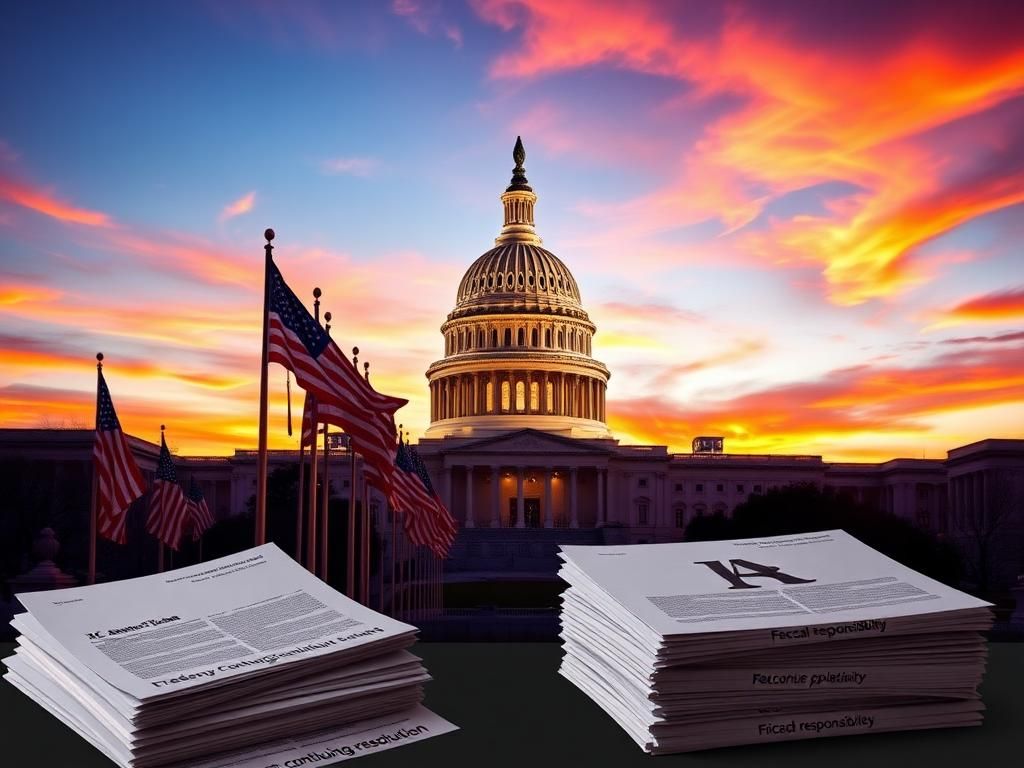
[0,140,1024,584]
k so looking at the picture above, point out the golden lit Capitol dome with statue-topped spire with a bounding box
[426,138,610,437]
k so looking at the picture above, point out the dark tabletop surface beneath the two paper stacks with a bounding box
[0,643,1024,768]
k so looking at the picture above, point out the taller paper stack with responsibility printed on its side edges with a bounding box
[560,530,992,754]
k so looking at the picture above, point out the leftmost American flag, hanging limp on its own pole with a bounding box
[92,371,144,544]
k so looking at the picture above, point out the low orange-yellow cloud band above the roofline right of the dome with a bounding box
[608,341,1024,460]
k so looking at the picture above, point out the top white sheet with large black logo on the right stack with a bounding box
[561,530,990,646]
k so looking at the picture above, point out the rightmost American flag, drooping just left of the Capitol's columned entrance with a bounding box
[391,440,456,558]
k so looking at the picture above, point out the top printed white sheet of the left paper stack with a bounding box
[17,544,416,700]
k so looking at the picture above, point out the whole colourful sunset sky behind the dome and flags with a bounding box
[0,0,1024,461]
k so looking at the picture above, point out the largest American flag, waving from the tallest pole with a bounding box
[267,263,408,495]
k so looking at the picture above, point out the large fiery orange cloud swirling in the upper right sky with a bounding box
[475,0,1024,305]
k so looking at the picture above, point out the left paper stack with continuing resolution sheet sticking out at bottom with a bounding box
[4,544,454,768]
